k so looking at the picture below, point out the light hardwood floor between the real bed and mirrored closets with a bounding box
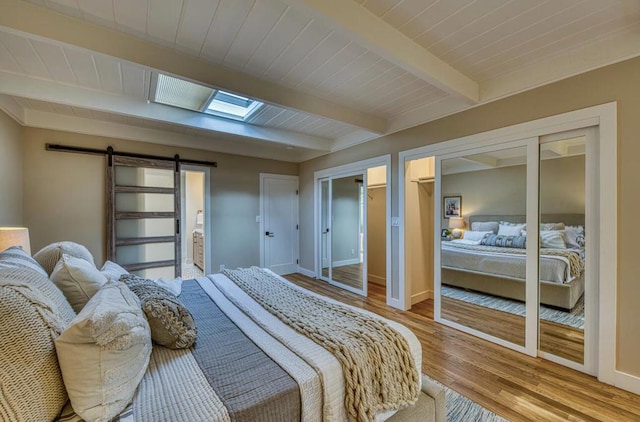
[286,274,640,422]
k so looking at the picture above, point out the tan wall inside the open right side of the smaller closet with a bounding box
[366,187,387,285]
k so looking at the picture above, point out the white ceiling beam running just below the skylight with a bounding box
[0,71,331,152]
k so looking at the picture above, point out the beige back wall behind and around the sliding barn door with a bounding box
[23,128,298,272]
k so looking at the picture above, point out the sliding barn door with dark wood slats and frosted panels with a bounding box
[107,156,181,279]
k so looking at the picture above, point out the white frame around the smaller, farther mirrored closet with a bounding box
[313,154,392,304]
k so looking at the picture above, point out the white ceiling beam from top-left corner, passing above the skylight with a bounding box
[0,0,387,133]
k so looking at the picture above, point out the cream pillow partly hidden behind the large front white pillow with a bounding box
[51,254,107,312]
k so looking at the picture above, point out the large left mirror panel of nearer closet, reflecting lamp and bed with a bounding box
[436,142,536,351]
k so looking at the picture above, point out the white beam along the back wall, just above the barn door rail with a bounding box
[25,109,324,163]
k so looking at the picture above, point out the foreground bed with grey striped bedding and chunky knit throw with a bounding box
[0,244,445,422]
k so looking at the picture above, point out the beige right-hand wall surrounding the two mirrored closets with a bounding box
[300,58,640,376]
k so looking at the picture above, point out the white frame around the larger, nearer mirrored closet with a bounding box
[392,102,616,388]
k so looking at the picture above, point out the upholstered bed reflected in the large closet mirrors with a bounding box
[441,214,584,309]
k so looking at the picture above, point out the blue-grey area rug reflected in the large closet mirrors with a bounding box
[441,285,584,329]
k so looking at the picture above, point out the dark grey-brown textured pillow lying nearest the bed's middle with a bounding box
[120,274,197,349]
